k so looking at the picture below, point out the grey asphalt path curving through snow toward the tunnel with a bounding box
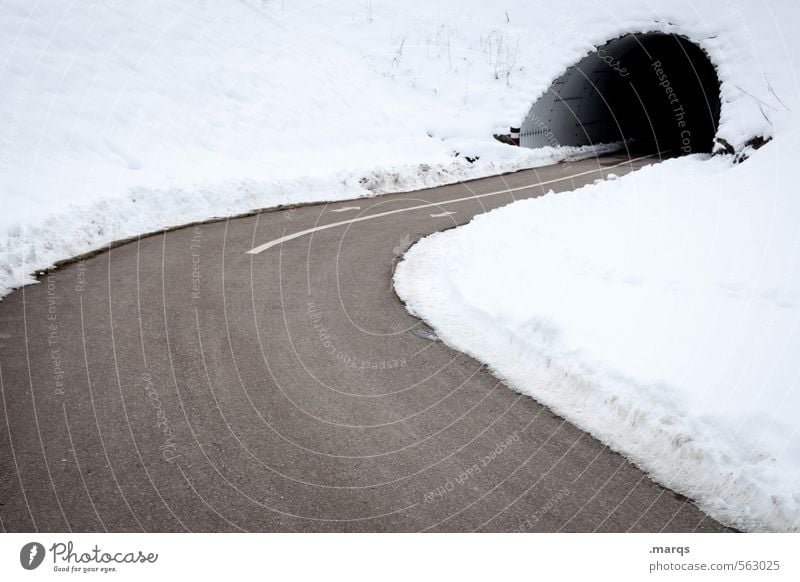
[0,157,722,532]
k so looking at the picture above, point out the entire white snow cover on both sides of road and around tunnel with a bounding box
[0,0,800,530]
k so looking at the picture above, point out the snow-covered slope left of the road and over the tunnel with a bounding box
[0,0,780,297]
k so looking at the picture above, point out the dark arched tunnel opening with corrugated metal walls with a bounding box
[520,32,720,155]
